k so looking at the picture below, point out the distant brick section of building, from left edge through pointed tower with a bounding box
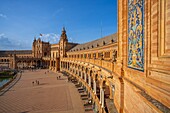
[0,28,77,69]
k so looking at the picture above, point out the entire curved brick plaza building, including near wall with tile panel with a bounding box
[0,0,170,113]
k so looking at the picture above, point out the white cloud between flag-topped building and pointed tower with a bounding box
[40,33,60,44]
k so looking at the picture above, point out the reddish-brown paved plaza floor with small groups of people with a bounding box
[0,70,84,113]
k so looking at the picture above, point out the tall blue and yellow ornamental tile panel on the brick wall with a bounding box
[128,0,144,71]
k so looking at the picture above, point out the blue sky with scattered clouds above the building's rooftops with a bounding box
[0,0,117,50]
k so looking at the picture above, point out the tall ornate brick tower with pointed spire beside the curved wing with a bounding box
[59,27,68,57]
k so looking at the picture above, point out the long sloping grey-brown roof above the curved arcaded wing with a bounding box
[69,33,117,52]
